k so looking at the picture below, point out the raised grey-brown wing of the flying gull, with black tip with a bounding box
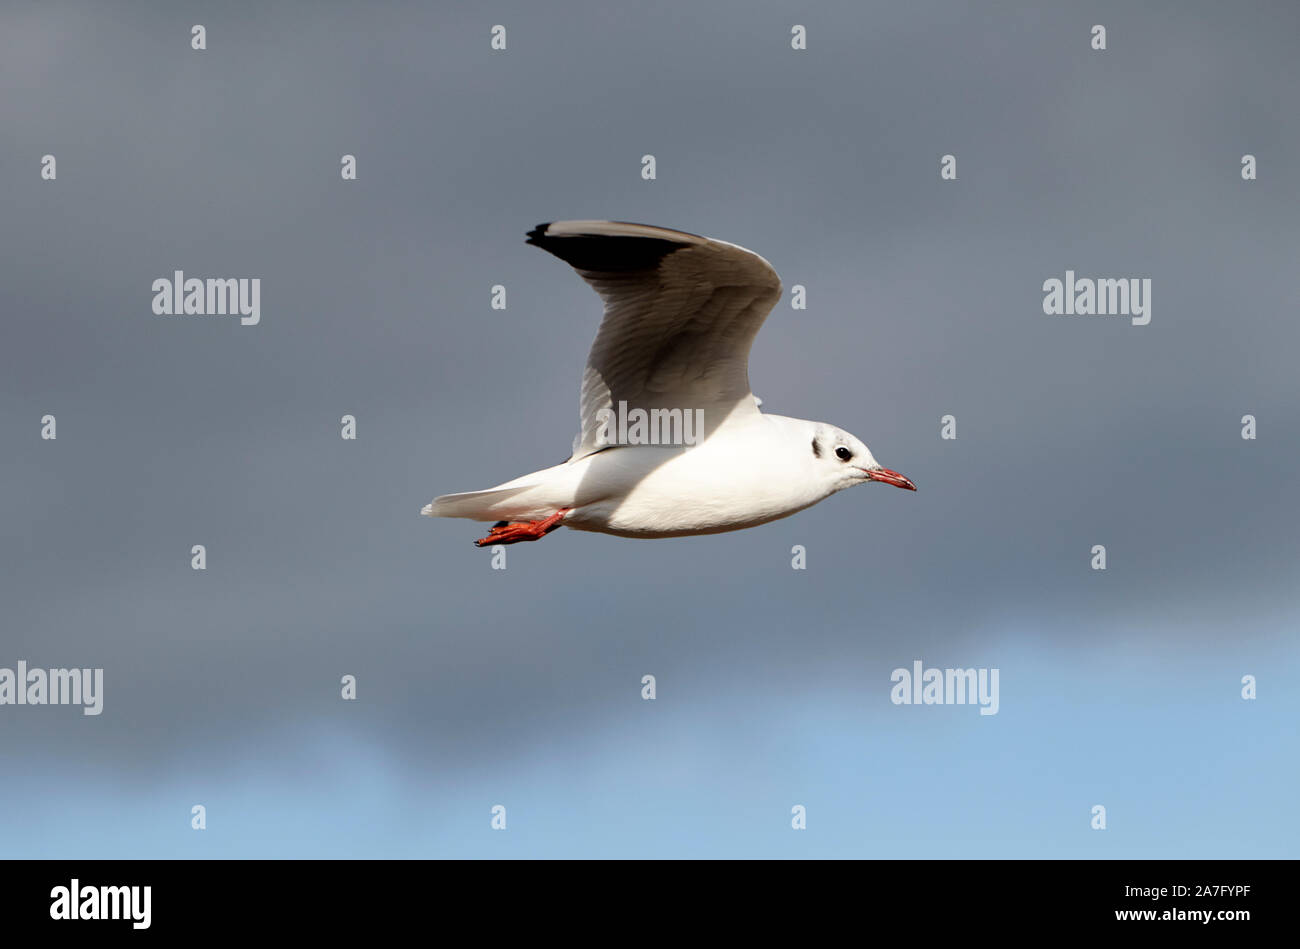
[528,221,781,459]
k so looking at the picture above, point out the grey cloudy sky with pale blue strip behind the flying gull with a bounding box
[0,0,1300,857]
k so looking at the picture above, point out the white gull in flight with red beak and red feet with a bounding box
[421,221,917,547]
